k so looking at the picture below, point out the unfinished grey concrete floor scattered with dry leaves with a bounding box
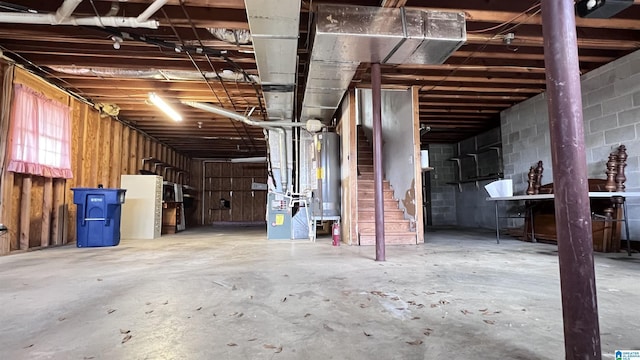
[0,228,640,360]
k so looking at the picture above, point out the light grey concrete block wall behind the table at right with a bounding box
[501,47,640,240]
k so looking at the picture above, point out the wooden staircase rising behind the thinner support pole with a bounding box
[357,126,417,245]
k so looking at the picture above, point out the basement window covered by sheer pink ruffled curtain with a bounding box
[7,84,73,179]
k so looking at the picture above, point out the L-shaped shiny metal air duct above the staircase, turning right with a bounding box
[301,4,466,123]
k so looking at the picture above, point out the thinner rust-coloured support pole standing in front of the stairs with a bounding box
[371,64,386,261]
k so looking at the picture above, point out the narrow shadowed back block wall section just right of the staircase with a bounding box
[429,144,458,226]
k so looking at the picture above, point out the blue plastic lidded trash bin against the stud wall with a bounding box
[71,188,127,247]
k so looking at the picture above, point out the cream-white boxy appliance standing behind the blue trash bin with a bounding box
[120,175,162,239]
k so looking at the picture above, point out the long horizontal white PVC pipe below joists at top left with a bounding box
[0,12,159,29]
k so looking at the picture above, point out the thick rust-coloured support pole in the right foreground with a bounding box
[542,0,602,360]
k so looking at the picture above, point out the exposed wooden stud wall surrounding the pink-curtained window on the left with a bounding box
[0,64,193,255]
